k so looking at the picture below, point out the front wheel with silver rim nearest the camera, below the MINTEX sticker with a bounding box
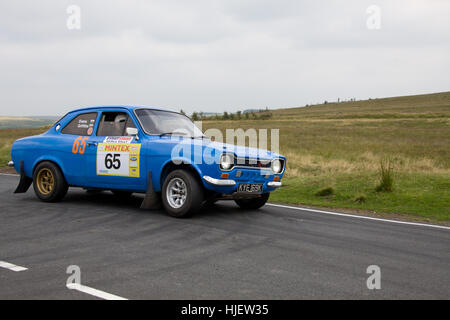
[161,170,204,218]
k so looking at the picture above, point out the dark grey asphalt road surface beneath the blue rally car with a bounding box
[0,175,450,299]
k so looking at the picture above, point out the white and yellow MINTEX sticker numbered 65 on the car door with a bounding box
[97,143,141,178]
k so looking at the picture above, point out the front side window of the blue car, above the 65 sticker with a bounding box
[97,112,136,137]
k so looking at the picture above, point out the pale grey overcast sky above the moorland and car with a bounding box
[0,0,450,116]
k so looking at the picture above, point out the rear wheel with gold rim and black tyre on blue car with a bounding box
[33,161,69,202]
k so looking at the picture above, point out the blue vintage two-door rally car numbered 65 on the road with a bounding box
[10,106,286,217]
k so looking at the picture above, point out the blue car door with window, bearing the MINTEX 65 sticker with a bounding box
[86,109,146,191]
